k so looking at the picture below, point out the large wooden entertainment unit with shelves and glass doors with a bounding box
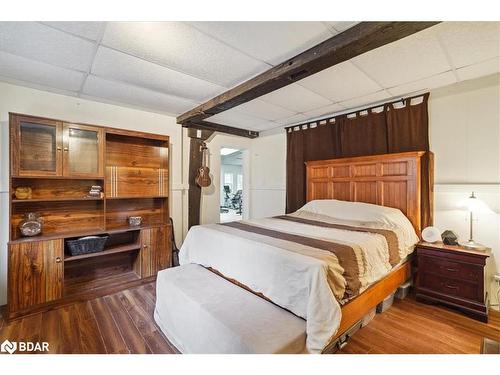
[7,113,172,319]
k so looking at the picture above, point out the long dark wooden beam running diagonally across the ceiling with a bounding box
[177,22,439,127]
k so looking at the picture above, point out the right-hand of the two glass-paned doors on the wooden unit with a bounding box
[63,123,104,177]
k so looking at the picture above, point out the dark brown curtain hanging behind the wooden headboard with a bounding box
[286,93,433,227]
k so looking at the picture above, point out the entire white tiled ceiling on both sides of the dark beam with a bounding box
[0,21,500,130]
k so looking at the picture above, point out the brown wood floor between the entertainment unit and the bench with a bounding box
[0,283,178,354]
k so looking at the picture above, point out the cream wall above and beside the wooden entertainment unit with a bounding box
[0,83,186,305]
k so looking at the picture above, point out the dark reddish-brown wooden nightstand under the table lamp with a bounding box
[416,242,491,322]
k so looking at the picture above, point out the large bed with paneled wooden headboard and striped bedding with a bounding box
[180,152,424,353]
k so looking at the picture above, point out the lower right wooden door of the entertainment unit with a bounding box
[140,226,172,277]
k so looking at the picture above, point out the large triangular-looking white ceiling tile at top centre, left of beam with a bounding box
[190,22,332,65]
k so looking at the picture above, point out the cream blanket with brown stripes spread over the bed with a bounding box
[180,211,413,353]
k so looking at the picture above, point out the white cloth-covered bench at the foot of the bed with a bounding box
[154,264,306,353]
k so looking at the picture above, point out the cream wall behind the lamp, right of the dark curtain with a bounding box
[429,74,500,303]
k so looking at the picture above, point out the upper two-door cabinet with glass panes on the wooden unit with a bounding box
[10,114,104,177]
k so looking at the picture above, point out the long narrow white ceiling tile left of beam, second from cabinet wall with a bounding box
[92,47,227,102]
